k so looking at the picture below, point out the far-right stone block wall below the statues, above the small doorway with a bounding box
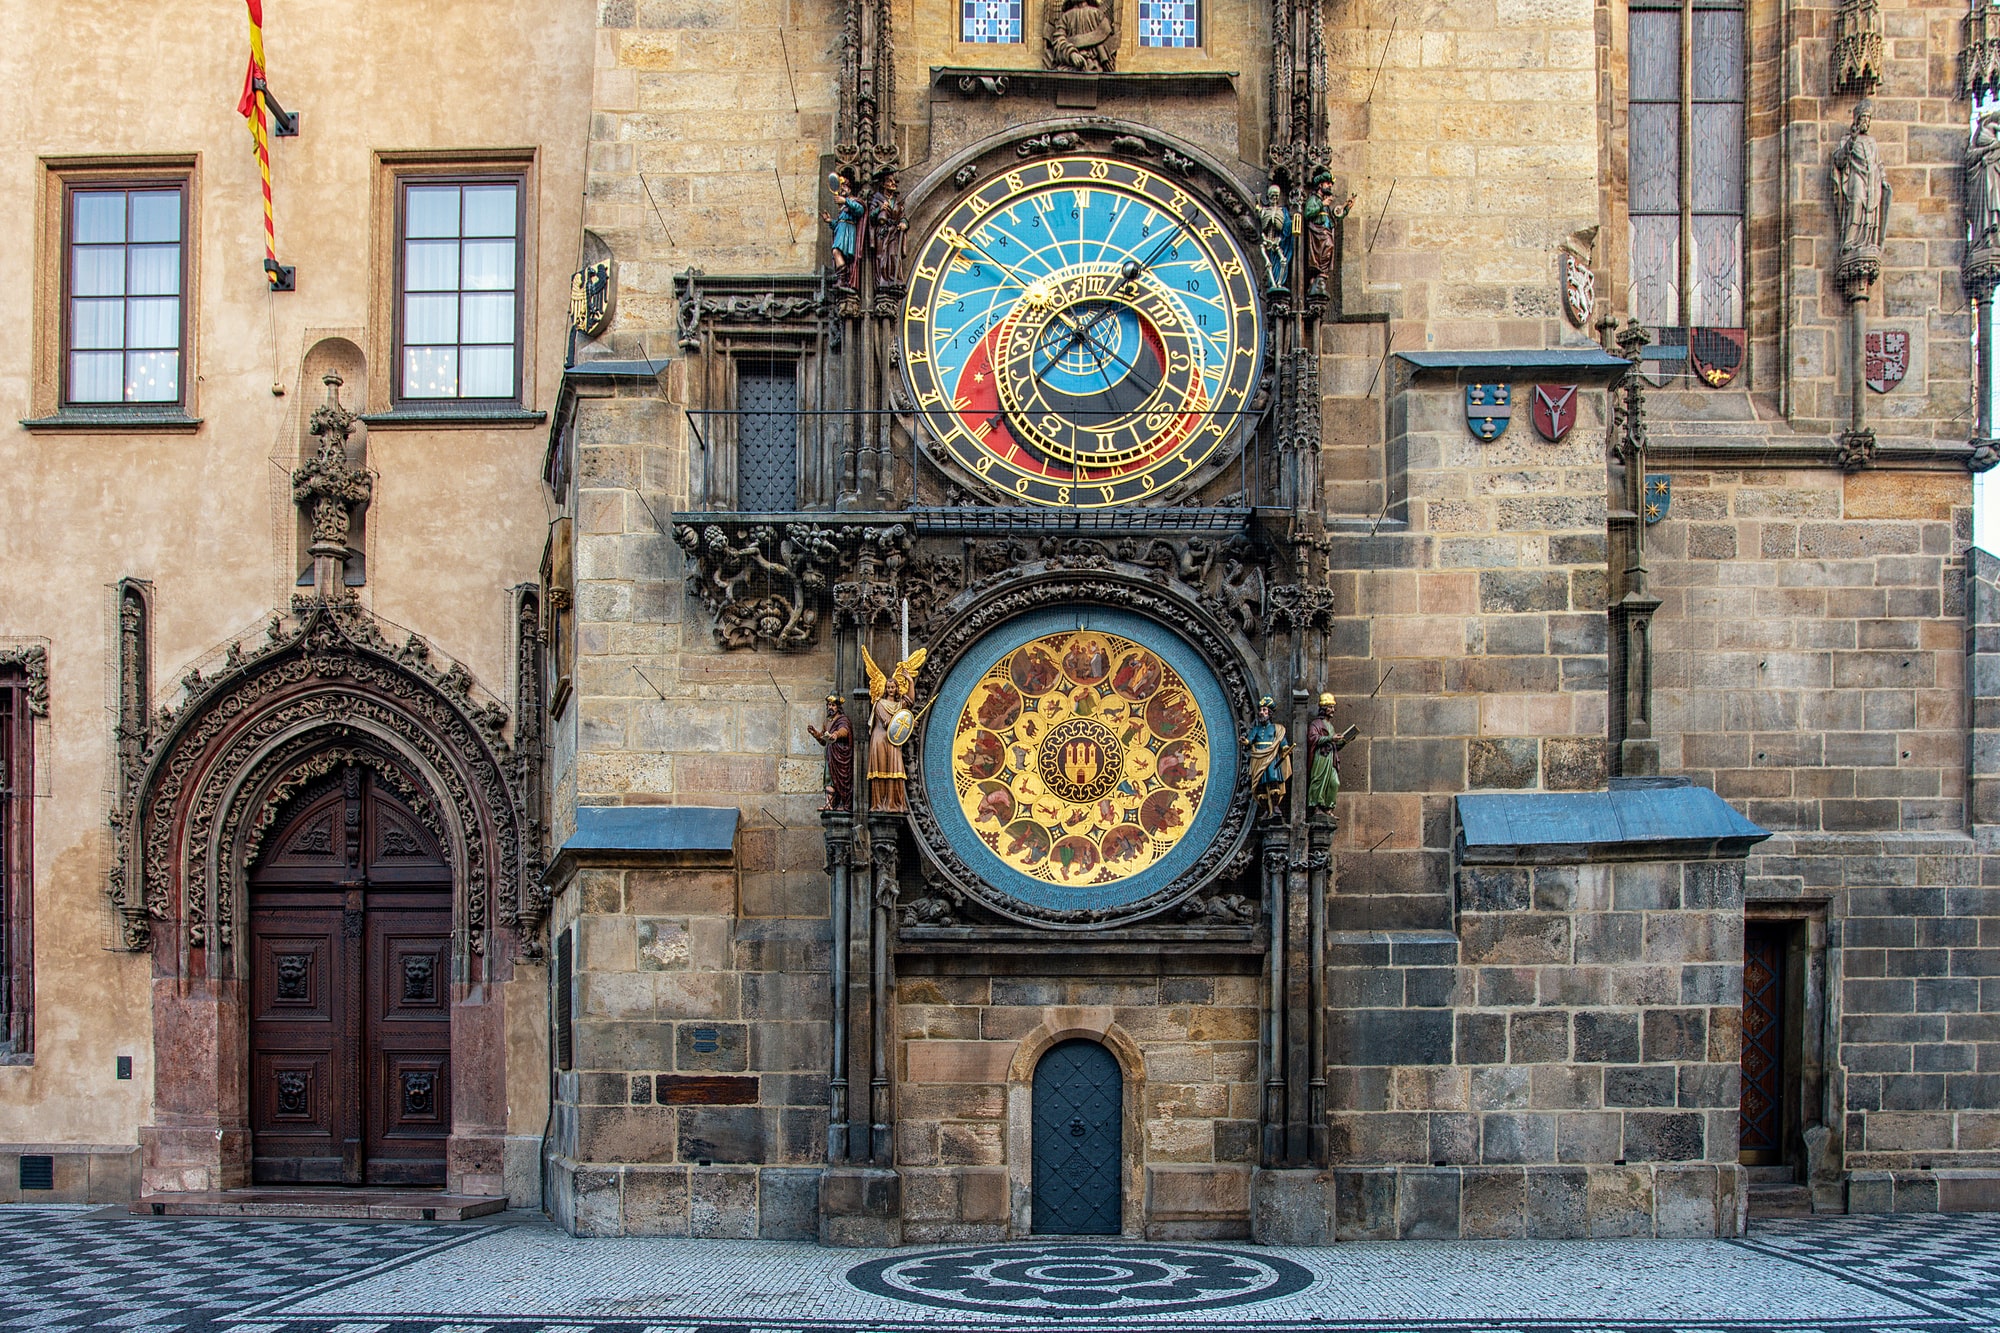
[1646,468,1972,833]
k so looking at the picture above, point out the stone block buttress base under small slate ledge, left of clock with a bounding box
[548,852,828,1239]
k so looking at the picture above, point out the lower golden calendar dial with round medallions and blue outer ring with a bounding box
[924,608,1238,911]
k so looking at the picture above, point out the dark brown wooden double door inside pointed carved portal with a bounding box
[248,765,452,1185]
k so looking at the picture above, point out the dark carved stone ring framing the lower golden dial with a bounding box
[908,562,1262,931]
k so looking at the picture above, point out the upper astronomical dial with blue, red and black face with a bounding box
[902,156,1264,508]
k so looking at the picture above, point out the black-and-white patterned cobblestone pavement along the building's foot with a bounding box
[0,1207,2000,1333]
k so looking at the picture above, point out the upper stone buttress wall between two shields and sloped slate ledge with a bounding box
[1328,370,1606,929]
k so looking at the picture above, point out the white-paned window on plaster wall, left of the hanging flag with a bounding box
[62,184,186,404]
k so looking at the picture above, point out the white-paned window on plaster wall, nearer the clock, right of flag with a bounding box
[396,176,524,402]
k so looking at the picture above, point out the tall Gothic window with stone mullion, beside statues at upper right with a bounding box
[1626,0,1744,328]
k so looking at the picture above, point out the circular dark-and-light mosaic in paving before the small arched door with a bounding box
[848,1241,1312,1315]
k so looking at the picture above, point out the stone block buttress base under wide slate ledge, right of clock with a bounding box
[1326,861,1742,1239]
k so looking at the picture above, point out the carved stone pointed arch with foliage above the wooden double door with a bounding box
[108,598,548,951]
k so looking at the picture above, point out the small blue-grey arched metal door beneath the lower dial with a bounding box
[1032,1041,1124,1235]
